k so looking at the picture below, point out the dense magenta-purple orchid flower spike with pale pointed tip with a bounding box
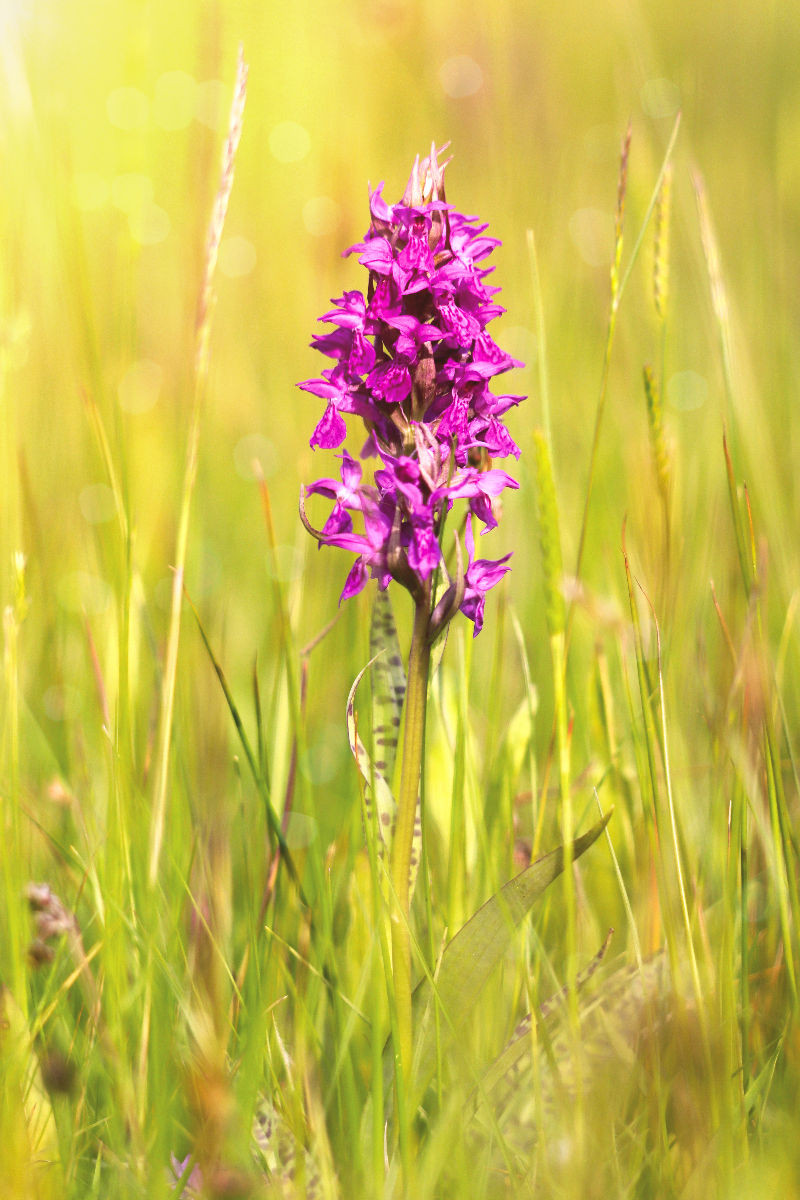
[300,146,524,637]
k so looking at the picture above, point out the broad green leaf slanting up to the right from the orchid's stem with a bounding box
[402,810,613,1099]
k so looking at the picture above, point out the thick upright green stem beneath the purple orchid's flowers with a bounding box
[391,594,431,1087]
